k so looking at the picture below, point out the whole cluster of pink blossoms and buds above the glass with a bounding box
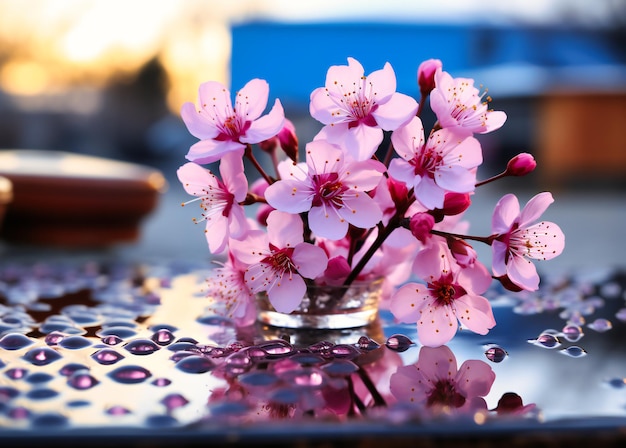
[178,58,564,346]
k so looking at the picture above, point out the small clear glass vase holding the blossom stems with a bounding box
[257,278,383,329]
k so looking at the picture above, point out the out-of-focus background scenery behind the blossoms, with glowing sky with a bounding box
[0,0,626,267]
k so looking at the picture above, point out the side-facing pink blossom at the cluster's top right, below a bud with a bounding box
[430,69,506,135]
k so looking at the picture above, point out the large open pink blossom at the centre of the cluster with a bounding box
[265,140,384,240]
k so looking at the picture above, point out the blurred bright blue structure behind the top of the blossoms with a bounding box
[231,22,625,107]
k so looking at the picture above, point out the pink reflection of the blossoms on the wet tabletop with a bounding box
[202,340,535,423]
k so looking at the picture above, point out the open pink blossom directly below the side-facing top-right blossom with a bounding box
[389,117,483,210]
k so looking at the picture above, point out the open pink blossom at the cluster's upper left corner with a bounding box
[181,79,285,164]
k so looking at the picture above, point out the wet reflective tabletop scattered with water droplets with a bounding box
[0,256,626,447]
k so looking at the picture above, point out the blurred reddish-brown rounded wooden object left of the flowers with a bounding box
[0,150,166,248]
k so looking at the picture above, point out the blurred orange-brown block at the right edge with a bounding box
[536,91,626,188]
